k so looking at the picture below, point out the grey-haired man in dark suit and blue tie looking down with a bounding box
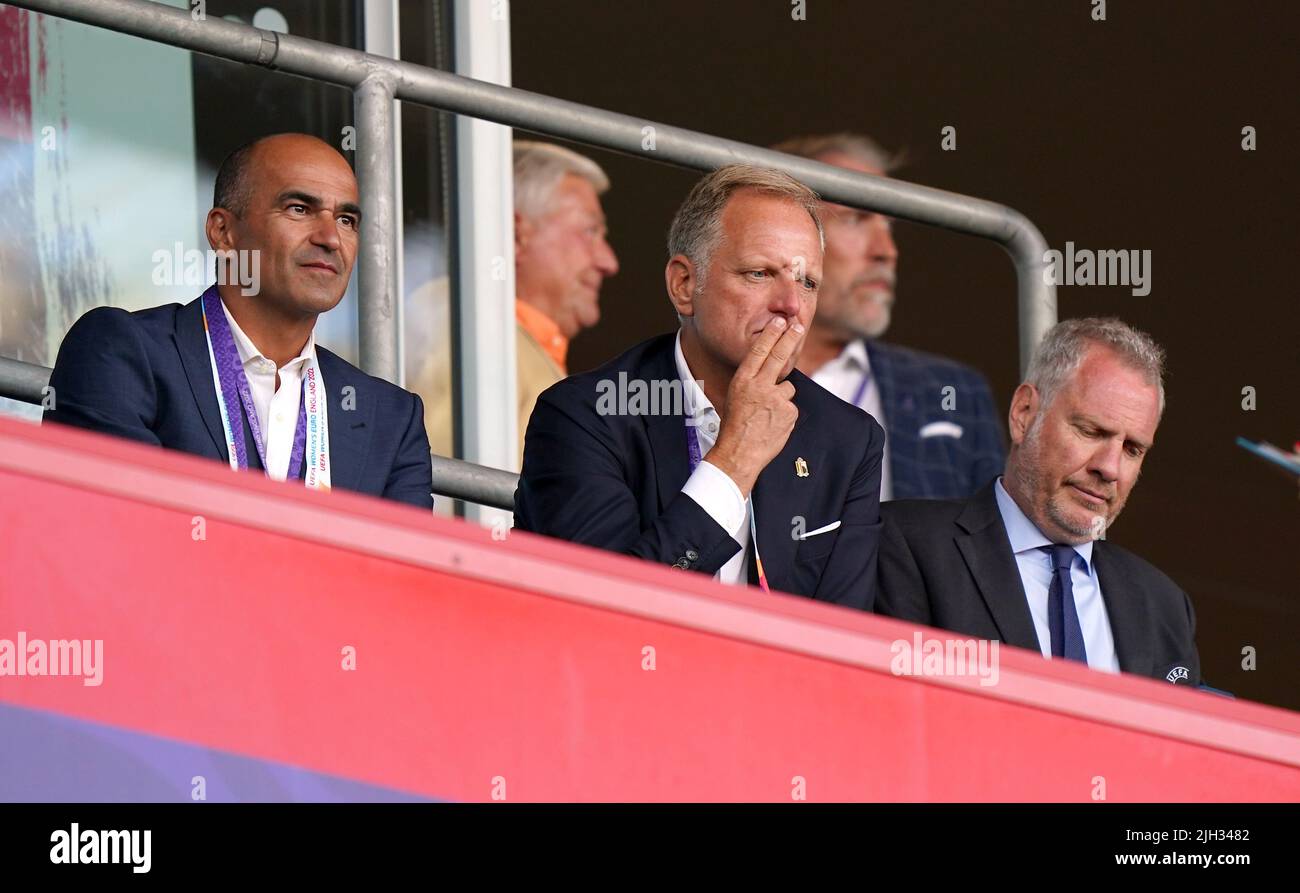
[878,320,1200,685]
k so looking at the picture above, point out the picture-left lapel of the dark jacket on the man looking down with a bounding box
[956,485,1040,651]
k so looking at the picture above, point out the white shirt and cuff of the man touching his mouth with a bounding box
[673,329,750,586]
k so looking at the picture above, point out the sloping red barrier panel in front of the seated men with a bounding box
[0,419,1300,801]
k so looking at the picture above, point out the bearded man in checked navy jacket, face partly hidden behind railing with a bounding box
[774,134,1004,500]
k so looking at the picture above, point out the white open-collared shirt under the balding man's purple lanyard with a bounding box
[221,302,316,481]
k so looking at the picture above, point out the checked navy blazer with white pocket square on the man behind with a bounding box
[866,341,1006,499]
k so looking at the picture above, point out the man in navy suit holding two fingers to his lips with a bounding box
[515,165,884,610]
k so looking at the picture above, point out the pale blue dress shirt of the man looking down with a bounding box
[993,478,1119,673]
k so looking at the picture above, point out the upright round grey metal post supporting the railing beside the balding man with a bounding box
[354,73,402,383]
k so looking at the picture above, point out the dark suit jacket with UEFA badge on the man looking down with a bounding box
[876,484,1201,685]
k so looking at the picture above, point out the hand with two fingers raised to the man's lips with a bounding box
[707,316,803,498]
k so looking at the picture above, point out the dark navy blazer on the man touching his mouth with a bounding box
[515,334,884,611]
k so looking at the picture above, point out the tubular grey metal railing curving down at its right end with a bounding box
[0,0,1057,510]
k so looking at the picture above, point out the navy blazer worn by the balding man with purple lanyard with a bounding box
[44,291,433,508]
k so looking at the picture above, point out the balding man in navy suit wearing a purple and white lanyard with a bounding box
[44,134,433,508]
